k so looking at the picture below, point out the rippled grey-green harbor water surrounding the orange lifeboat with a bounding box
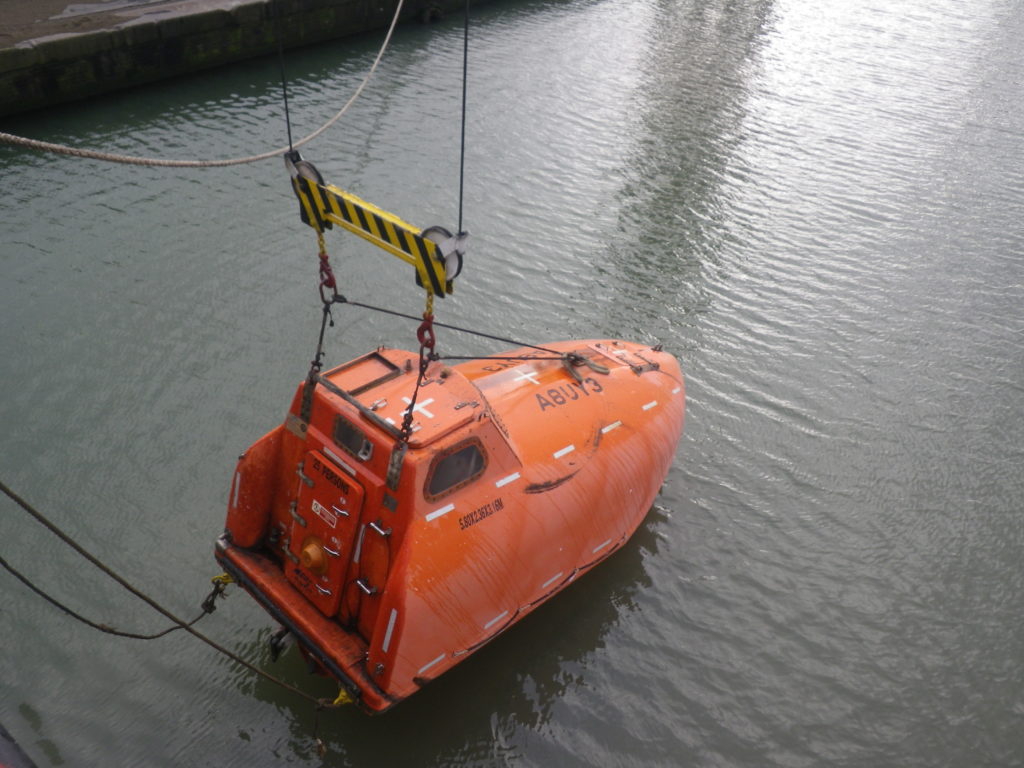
[0,0,1024,768]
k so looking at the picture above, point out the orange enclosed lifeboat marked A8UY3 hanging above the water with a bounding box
[216,341,684,712]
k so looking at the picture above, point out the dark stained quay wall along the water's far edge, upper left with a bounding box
[0,0,465,116]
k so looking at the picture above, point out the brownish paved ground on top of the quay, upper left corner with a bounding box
[0,0,229,48]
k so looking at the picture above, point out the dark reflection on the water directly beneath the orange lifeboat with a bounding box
[232,506,667,766]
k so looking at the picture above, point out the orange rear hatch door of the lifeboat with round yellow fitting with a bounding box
[285,451,362,616]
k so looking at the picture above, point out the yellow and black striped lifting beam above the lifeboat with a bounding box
[285,152,467,298]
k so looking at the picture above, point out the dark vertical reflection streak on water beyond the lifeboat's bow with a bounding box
[607,2,772,336]
